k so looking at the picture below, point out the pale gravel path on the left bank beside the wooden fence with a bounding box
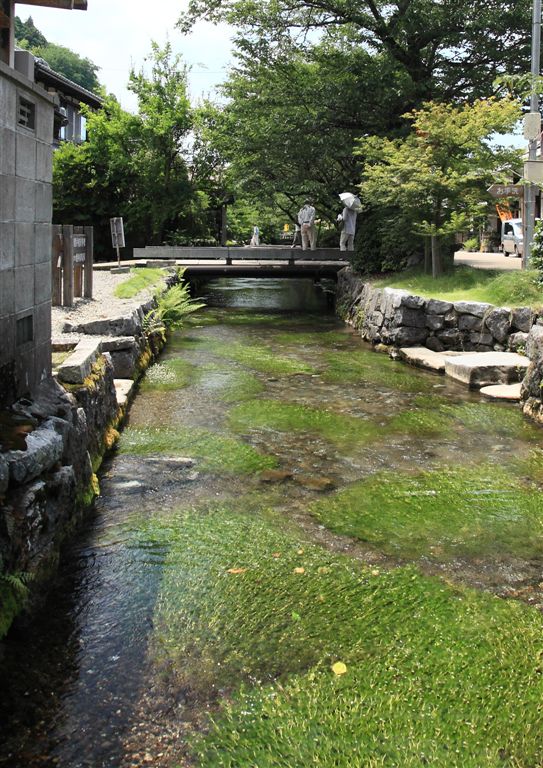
[52,270,165,344]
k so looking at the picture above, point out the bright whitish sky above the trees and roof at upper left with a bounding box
[15,0,231,110]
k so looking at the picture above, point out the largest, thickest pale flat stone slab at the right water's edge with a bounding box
[445,352,530,389]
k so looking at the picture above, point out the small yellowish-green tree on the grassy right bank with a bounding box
[359,98,521,277]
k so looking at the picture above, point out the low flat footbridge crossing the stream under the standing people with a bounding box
[130,245,350,279]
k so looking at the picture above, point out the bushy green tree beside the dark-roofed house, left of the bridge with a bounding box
[53,44,203,255]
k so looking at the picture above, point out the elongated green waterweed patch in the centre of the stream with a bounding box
[228,399,380,445]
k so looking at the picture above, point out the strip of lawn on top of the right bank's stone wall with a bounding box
[373,266,543,307]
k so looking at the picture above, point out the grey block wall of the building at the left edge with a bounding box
[0,62,55,407]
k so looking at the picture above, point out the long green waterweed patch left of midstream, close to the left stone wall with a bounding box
[119,427,277,474]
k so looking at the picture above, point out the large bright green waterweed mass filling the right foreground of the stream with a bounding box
[137,509,543,768]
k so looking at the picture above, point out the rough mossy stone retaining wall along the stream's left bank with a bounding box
[0,300,164,638]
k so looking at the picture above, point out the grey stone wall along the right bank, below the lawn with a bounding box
[336,267,543,352]
